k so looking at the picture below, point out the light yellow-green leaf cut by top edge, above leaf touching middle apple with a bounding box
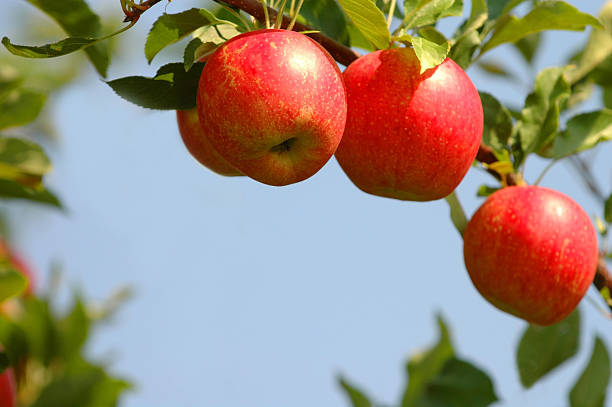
[402,0,463,30]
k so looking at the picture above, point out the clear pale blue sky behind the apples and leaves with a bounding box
[0,0,612,407]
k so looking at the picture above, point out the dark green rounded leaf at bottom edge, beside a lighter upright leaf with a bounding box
[415,357,498,407]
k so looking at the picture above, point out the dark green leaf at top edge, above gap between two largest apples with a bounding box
[300,0,352,45]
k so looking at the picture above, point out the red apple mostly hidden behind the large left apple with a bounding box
[176,109,243,177]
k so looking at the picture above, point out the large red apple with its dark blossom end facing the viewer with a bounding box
[197,29,347,186]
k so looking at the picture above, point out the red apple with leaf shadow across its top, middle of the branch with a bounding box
[336,48,483,201]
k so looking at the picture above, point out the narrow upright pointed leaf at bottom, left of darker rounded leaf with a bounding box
[401,316,454,407]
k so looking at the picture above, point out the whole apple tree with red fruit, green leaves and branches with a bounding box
[0,0,612,407]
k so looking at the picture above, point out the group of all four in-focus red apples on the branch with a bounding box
[177,29,598,325]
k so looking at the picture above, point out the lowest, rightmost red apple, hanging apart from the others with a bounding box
[463,186,598,325]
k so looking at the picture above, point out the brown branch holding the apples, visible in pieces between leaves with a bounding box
[124,0,612,309]
